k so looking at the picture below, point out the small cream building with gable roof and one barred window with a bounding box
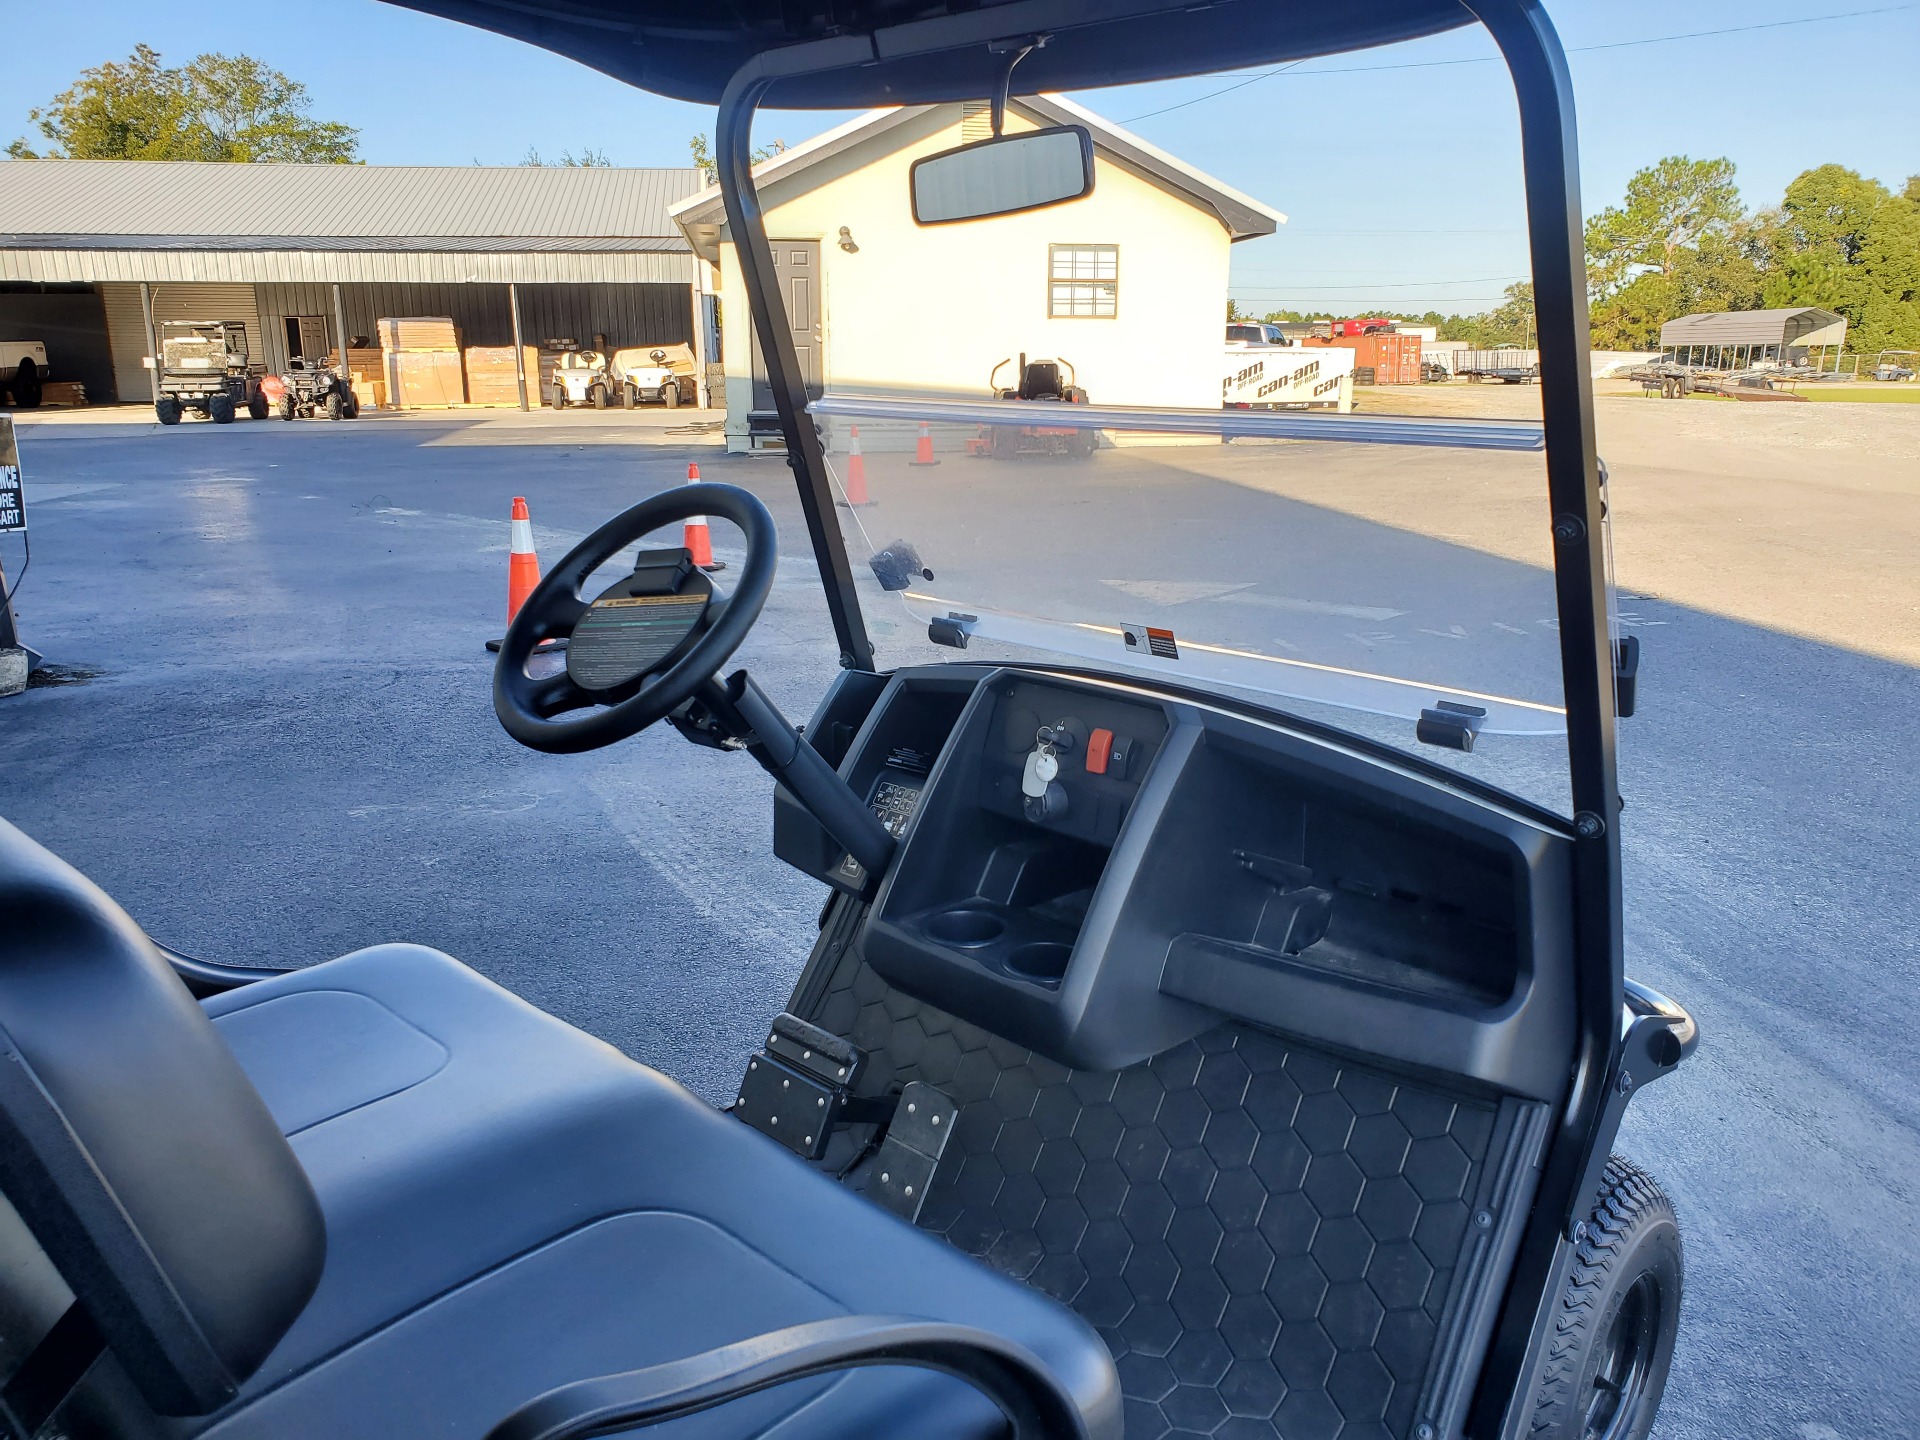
[672,96,1286,449]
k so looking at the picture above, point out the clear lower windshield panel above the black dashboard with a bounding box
[814,395,1567,810]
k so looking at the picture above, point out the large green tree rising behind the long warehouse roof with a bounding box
[8,44,359,163]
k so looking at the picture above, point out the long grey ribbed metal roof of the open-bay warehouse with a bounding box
[0,159,707,250]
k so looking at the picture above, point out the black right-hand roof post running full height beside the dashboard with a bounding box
[1463,0,1626,1440]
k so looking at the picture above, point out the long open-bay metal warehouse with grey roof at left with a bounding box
[0,159,714,403]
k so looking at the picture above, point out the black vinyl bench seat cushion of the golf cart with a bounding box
[169,945,1117,1440]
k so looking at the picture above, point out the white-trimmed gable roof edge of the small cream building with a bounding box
[668,94,1286,252]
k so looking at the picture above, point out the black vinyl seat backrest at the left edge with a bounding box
[0,820,326,1415]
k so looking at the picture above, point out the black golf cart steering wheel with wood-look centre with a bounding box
[493,484,778,755]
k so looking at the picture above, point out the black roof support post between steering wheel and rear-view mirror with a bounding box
[714,46,874,670]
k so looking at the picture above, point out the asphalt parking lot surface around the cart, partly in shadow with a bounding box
[0,390,1920,1440]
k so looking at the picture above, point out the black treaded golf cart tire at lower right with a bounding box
[1526,1156,1686,1440]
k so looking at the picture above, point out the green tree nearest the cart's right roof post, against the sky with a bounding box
[1586,156,1745,296]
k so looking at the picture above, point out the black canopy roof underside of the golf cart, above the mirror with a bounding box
[378,0,1473,109]
